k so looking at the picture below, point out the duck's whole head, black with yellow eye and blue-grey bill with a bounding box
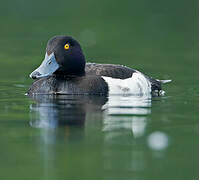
[30,36,85,79]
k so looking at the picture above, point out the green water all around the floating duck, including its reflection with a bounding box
[0,0,199,180]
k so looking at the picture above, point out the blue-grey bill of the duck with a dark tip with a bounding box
[30,53,59,79]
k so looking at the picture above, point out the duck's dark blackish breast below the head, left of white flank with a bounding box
[28,75,108,95]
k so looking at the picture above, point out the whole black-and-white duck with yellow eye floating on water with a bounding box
[27,35,170,96]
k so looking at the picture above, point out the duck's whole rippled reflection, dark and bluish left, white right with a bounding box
[30,95,151,137]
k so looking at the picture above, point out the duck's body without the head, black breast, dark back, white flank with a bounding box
[28,63,161,95]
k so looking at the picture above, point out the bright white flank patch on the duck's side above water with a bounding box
[102,71,151,95]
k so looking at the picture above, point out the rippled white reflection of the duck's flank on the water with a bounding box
[103,96,151,137]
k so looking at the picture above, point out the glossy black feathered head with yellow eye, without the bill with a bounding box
[46,36,85,75]
